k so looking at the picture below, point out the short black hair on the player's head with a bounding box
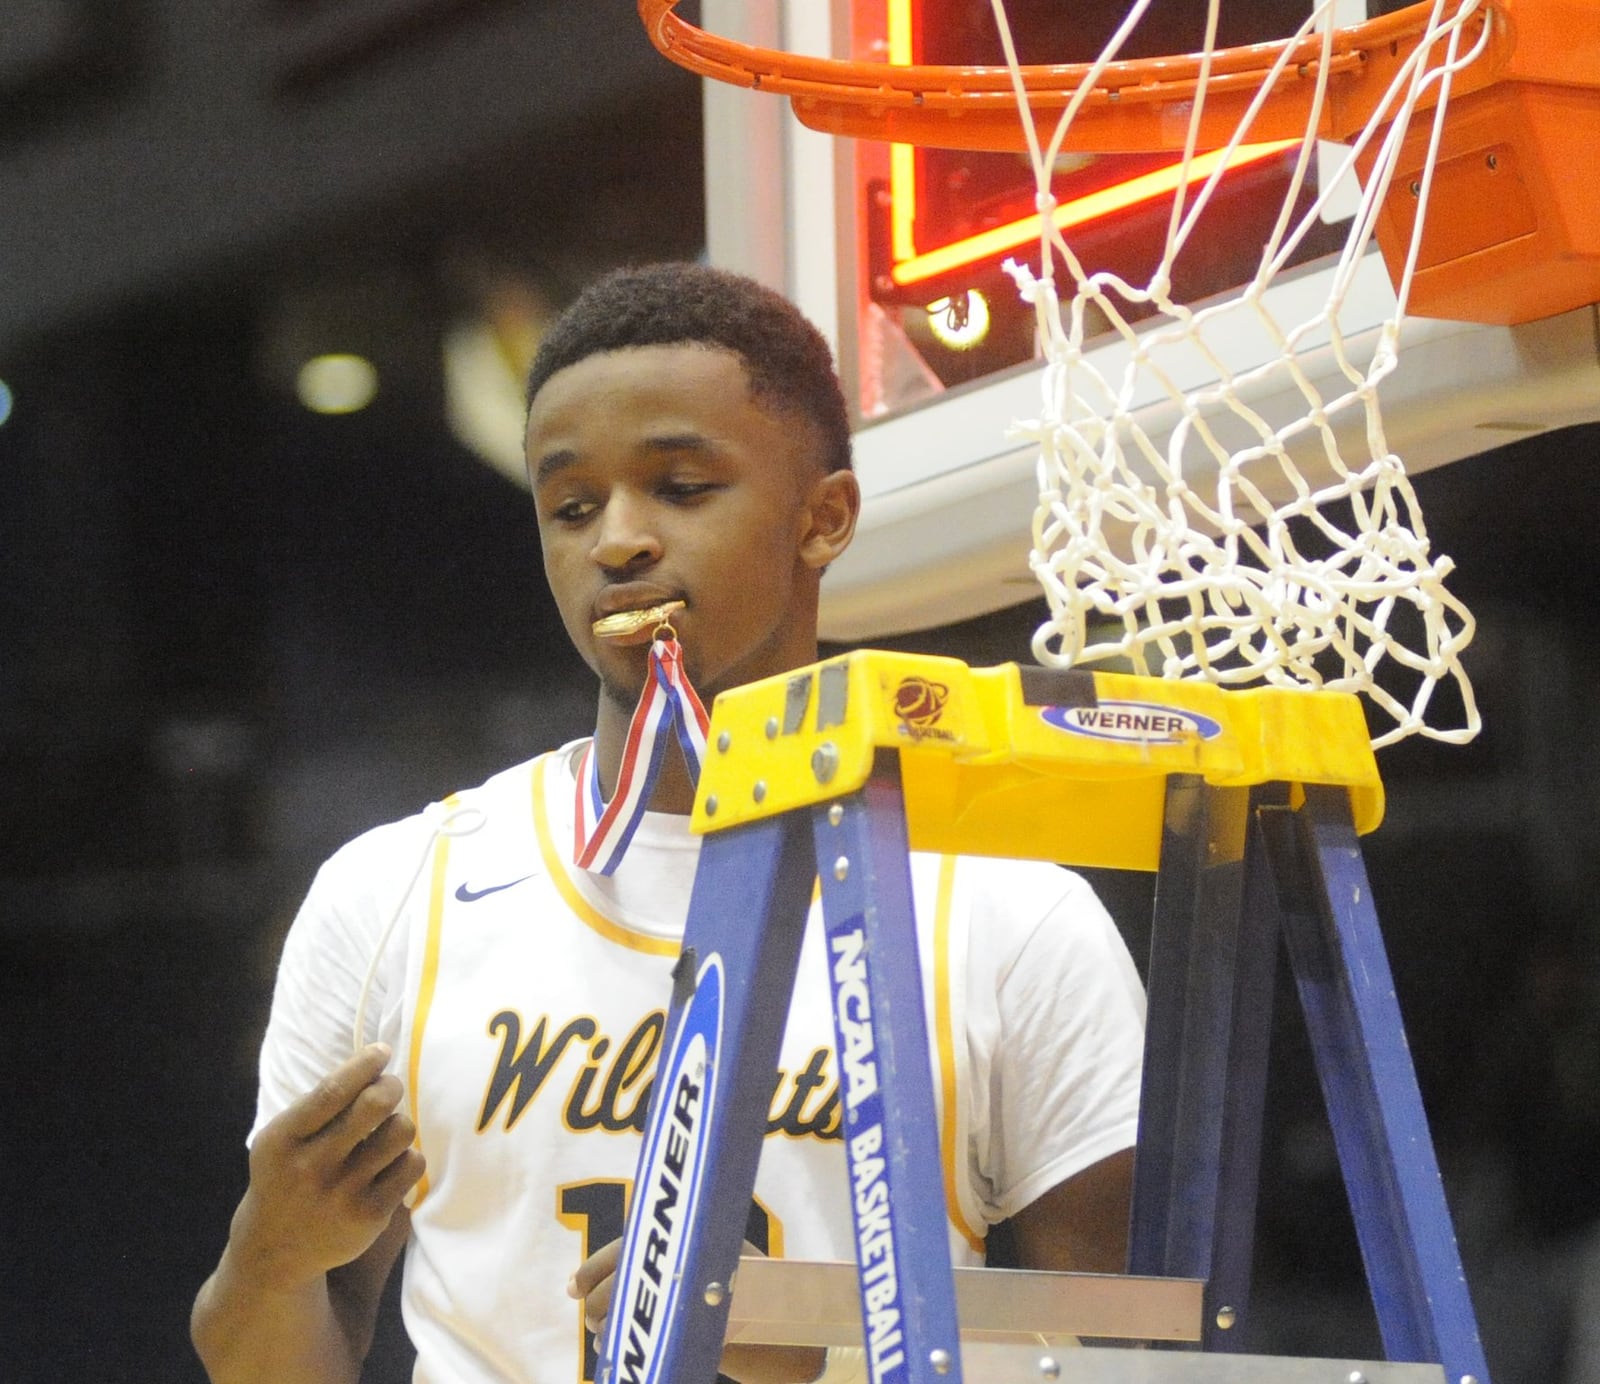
[528,262,850,470]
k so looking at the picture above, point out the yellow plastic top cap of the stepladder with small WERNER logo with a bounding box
[691,650,1384,870]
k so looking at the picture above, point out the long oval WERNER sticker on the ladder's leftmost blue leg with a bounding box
[602,954,725,1384]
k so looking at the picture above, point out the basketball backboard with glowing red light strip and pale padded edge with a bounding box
[701,0,1600,640]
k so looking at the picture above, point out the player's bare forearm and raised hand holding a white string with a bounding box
[190,1046,422,1384]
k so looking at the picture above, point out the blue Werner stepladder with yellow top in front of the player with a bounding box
[598,653,1488,1384]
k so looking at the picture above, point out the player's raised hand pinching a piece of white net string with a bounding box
[230,1043,424,1288]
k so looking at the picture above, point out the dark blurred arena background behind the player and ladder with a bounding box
[0,0,1600,1384]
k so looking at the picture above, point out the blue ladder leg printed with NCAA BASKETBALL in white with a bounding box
[814,754,962,1384]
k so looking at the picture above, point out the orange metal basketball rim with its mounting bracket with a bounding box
[638,0,1600,323]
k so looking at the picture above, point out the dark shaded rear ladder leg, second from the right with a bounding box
[1130,776,1277,1349]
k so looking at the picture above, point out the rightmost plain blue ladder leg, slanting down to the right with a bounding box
[1262,786,1488,1384]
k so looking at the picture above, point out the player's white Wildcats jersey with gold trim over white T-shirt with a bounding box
[256,746,1144,1384]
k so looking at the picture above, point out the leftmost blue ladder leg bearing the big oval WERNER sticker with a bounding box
[598,811,816,1384]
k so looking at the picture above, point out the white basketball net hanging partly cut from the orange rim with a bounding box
[992,0,1490,746]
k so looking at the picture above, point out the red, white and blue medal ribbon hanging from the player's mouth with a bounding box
[573,638,710,875]
